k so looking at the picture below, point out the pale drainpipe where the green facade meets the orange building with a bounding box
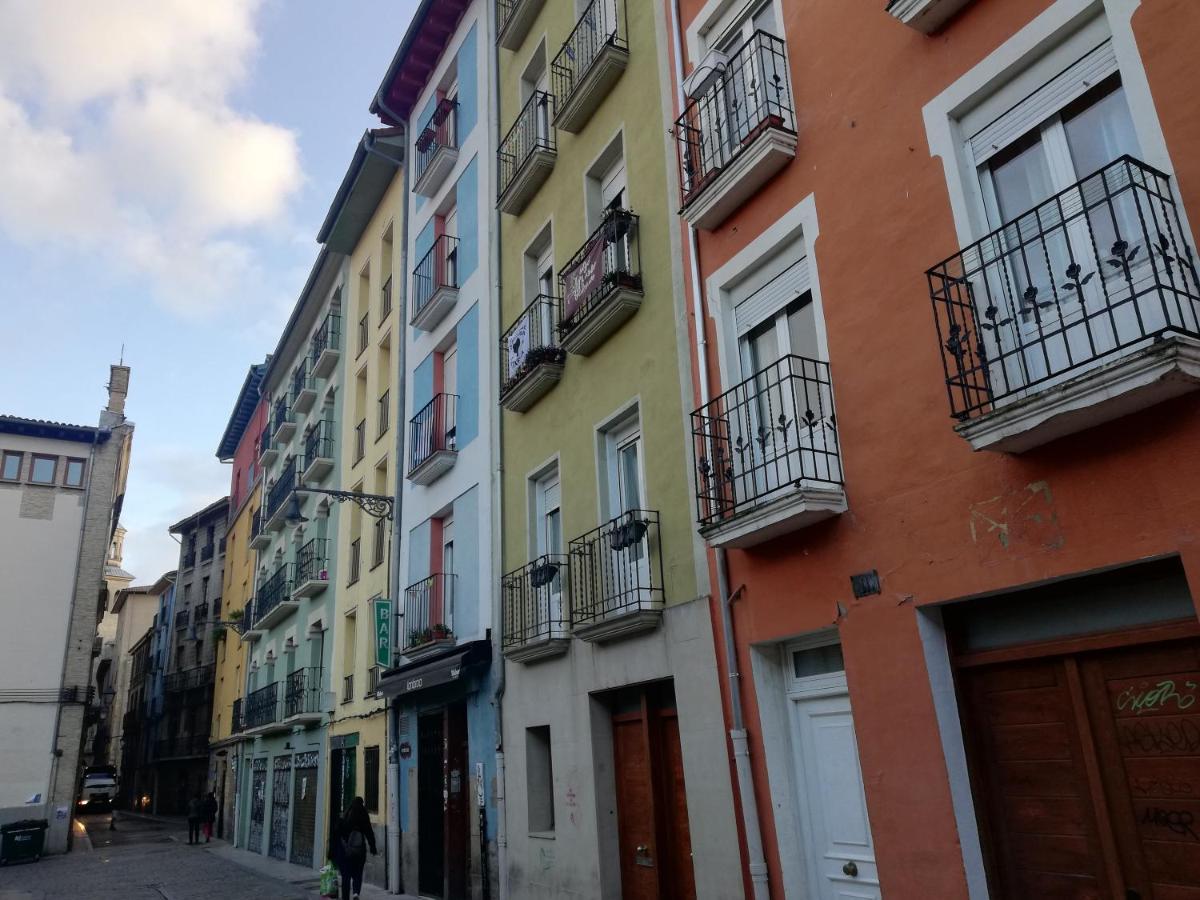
[671,0,770,900]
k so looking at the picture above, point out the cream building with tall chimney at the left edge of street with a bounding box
[0,366,133,853]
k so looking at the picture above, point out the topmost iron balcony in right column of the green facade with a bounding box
[550,0,629,133]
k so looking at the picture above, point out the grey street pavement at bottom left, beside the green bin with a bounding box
[0,812,314,900]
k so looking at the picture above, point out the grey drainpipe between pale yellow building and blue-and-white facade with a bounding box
[365,105,409,894]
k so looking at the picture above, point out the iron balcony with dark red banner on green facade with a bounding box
[558,209,642,355]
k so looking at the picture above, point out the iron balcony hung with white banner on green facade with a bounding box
[500,294,566,413]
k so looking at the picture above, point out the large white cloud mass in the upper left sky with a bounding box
[0,0,304,316]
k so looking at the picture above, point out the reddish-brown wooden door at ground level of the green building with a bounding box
[612,688,696,900]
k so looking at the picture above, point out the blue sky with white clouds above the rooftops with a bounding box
[0,0,415,582]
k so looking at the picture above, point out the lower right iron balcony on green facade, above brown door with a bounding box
[566,509,662,642]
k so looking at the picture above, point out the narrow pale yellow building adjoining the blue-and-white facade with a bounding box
[318,128,404,884]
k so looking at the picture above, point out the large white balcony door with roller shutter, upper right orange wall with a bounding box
[968,41,1142,396]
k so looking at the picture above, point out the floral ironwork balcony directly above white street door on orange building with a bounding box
[691,356,846,547]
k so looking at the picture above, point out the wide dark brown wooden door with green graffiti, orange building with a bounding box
[959,641,1200,900]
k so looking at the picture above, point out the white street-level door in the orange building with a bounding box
[788,673,882,900]
